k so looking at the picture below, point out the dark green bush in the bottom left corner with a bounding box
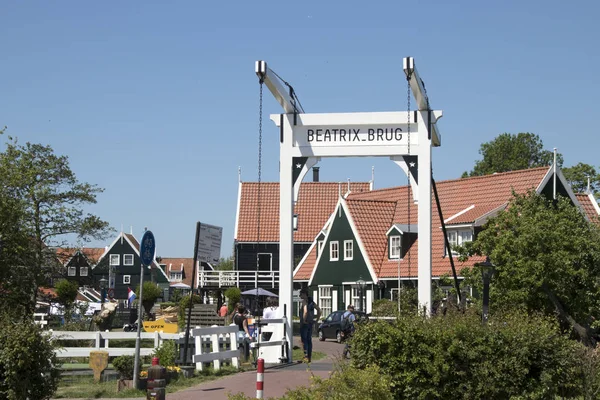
[0,313,60,400]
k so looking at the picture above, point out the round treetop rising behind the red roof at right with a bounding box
[462,132,563,178]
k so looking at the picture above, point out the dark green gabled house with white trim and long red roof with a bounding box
[294,167,600,315]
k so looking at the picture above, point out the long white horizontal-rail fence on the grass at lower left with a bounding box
[48,330,180,358]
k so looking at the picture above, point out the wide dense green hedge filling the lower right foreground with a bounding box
[352,313,582,399]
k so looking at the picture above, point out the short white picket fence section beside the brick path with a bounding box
[192,325,240,371]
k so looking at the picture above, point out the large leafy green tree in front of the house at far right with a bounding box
[463,191,600,346]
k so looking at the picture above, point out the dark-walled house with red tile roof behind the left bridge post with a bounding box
[229,167,372,291]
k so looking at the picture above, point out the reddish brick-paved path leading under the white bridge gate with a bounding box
[59,338,343,400]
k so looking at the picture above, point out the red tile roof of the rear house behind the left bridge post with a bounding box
[235,182,370,242]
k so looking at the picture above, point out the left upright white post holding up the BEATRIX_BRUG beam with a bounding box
[279,115,294,362]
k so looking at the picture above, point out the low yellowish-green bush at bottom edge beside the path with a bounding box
[229,363,394,400]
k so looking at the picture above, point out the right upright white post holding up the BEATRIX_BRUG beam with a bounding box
[417,111,433,315]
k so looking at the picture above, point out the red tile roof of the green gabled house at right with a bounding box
[294,167,580,280]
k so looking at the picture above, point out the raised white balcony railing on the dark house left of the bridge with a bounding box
[198,271,279,288]
